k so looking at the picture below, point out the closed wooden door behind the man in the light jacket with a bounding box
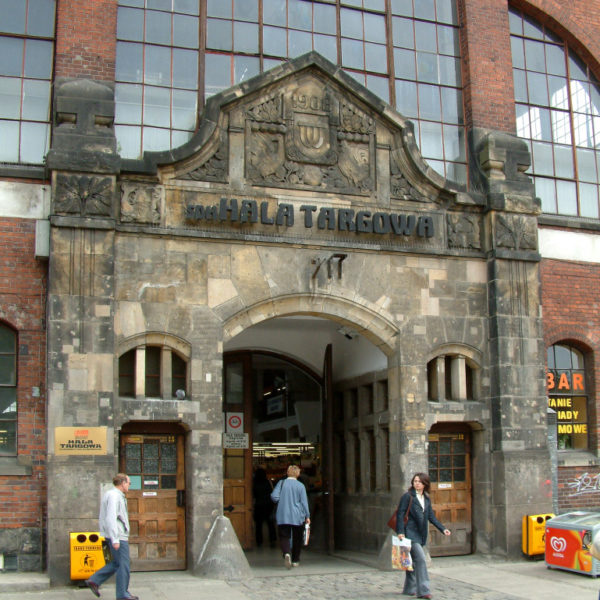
[120,433,186,571]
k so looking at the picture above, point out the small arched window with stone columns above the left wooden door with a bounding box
[119,334,190,400]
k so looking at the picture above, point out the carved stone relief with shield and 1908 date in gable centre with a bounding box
[245,82,375,193]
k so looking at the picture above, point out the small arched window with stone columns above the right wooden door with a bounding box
[427,349,479,402]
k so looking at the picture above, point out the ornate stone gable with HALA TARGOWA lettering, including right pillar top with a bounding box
[116,53,539,259]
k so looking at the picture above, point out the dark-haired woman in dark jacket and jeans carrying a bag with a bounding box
[396,473,450,598]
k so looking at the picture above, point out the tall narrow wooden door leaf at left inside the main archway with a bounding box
[223,353,254,550]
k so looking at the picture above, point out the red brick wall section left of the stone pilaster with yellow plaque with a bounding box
[0,218,47,570]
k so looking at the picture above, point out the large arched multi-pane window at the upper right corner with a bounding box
[510,9,600,219]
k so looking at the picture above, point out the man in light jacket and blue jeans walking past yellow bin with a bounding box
[85,473,139,600]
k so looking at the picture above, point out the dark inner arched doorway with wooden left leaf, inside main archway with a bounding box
[223,350,323,549]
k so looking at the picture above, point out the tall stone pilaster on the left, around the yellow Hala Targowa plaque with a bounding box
[48,79,120,583]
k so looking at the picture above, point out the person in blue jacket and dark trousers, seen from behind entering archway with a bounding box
[271,465,310,569]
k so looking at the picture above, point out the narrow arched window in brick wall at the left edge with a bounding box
[0,323,17,455]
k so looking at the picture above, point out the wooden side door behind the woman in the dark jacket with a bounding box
[428,425,472,556]
